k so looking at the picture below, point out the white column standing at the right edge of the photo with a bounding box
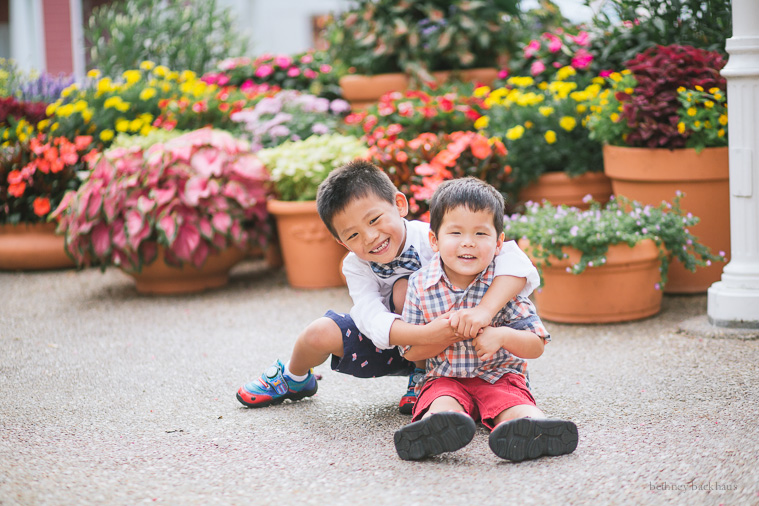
[707,0,759,329]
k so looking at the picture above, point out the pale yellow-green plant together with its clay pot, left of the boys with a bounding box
[258,133,367,288]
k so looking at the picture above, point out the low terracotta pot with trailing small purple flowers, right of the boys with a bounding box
[504,196,724,323]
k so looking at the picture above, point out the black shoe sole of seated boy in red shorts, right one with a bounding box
[488,418,577,462]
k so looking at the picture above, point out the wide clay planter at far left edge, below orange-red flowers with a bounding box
[0,223,74,271]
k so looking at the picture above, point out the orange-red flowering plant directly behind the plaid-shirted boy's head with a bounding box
[368,132,511,221]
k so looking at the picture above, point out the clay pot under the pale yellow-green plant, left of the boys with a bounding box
[266,200,347,288]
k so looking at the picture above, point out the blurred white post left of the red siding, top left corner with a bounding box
[8,0,47,72]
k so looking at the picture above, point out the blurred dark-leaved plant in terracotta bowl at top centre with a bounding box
[327,0,518,107]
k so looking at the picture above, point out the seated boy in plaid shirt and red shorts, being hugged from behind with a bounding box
[395,178,577,461]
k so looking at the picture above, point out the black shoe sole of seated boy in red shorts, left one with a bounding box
[394,412,475,460]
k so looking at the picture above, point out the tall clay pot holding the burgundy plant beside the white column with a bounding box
[603,146,730,293]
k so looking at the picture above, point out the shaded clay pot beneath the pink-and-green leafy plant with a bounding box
[128,247,246,294]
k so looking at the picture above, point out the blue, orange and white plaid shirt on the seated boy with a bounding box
[401,254,551,393]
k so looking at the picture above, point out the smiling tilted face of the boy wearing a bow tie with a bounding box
[332,192,408,264]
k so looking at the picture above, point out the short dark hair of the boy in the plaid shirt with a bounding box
[430,177,504,235]
